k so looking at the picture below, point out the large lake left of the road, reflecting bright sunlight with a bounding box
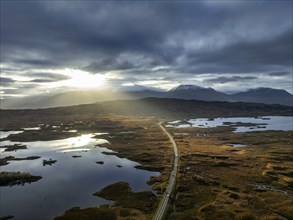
[0,132,159,220]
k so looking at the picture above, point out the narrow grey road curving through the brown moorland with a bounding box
[154,122,179,220]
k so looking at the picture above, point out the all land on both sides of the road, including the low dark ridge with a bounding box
[0,99,293,220]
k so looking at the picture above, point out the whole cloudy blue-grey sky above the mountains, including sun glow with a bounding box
[0,0,293,99]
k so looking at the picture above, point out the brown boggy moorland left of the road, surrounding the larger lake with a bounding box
[2,115,173,220]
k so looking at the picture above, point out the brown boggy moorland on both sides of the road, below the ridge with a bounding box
[1,114,293,220]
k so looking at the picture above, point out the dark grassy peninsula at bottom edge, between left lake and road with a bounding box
[54,182,158,220]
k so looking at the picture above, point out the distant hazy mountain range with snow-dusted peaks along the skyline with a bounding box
[1,85,293,109]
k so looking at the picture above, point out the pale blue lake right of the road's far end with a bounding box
[167,116,293,132]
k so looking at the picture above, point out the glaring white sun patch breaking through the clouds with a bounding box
[63,69,106,89]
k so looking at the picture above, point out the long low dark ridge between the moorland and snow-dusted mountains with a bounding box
[0,98,293,126]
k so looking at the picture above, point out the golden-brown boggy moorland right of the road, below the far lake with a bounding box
[167,124,293,220]
